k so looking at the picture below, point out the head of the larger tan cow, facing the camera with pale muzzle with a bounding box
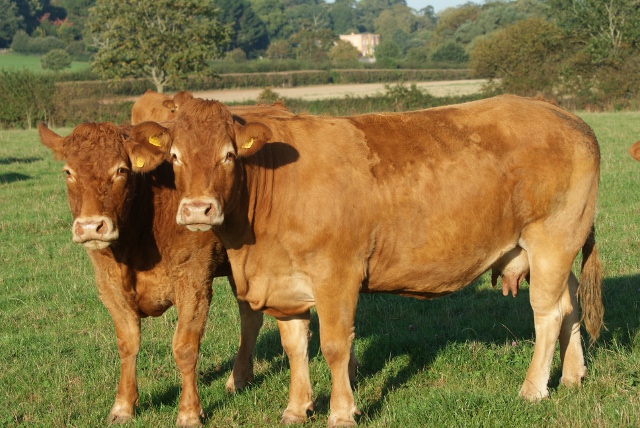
[161,99,271,231]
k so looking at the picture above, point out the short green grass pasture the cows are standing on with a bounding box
[0,113,640,428]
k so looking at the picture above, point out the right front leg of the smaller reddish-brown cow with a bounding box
[173,283,211,427]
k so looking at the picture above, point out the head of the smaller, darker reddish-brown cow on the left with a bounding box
[38,122,170,250]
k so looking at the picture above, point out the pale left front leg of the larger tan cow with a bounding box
[278,311,313,424]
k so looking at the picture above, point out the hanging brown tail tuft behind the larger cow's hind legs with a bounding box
[578,226,604,344]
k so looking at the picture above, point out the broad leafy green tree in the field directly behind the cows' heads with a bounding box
[86,0,230,92]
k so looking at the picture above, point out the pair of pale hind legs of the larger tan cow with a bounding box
[520,226,583,401]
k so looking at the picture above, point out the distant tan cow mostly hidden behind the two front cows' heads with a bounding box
[131,89,193,125]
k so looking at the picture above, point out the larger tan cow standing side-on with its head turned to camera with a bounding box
[132,96,603,426]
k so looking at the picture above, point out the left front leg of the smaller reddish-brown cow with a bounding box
[107,307,140,423]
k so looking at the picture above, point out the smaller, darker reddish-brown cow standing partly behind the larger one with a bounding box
[39,118,262,426]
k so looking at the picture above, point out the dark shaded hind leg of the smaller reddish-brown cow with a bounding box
[226,300,264,392]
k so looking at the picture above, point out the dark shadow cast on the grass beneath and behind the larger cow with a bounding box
[201,274,640,418]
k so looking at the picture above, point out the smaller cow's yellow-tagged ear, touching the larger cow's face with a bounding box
[125,122,171,172]
